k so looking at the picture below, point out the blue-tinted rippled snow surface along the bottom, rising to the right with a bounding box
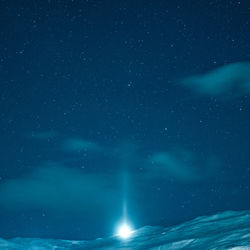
[0,211,250,250]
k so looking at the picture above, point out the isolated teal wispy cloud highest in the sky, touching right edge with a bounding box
[182,62,250,97]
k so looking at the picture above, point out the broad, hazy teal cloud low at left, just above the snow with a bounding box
[0,164,117,213]
